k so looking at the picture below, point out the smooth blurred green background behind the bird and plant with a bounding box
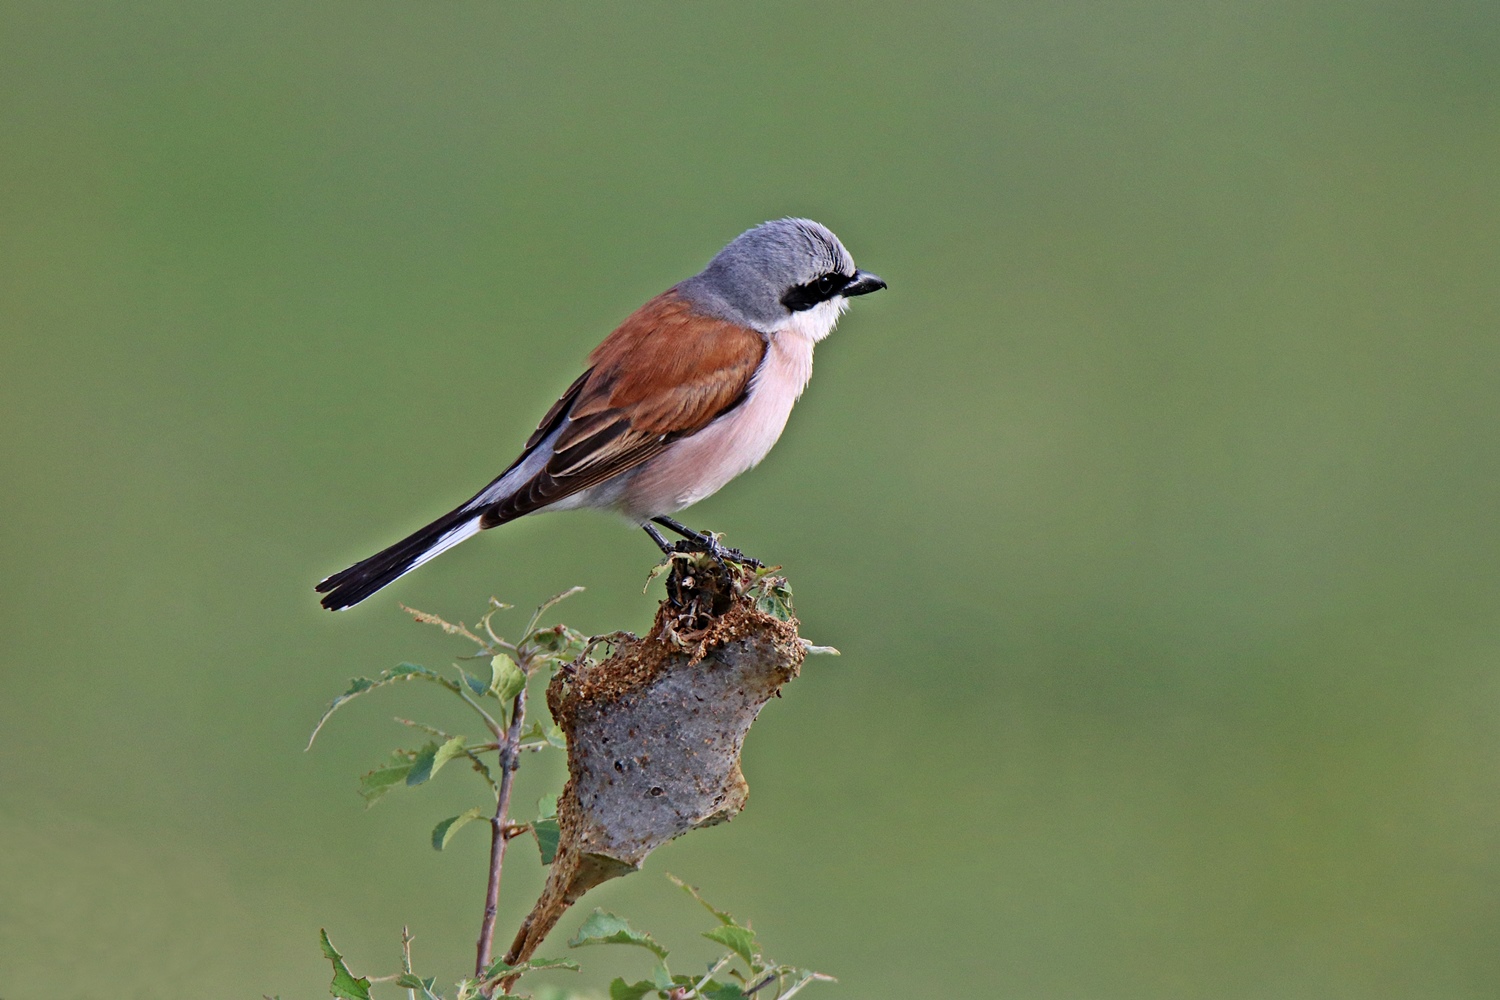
[0,0,1500,1000]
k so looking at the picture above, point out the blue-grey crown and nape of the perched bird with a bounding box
[677,219,855,330]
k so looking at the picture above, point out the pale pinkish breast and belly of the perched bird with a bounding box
[614,333,813,522]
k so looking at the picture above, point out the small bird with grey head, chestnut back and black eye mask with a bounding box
[315,217,887,610]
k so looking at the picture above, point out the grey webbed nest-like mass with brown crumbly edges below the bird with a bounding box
[506,577,809,964]
